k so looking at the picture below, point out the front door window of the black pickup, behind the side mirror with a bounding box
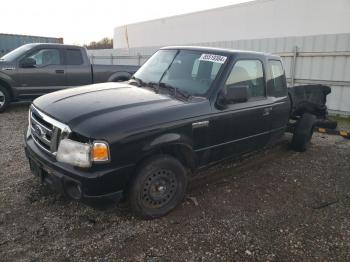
[225,60,265,98]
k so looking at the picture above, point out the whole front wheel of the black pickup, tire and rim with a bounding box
[129,155,187,219]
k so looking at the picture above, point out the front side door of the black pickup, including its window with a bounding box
[210,58,272,161]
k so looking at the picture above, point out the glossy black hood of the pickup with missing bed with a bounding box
[33,83,209,139]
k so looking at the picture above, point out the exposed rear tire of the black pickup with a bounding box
[291,113,316,152]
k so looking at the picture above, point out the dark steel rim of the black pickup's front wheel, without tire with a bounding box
[141,169,178,209]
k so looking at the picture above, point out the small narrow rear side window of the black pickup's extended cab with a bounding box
[269,60,287,97]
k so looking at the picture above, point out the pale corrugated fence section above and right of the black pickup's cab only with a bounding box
[199,33,350,115]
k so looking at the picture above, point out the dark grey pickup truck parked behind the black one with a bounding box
[0,44,139,112]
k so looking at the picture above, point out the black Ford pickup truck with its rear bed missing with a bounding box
[25,47,325,219]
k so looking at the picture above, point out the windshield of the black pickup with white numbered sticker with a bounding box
[134,50,226,96]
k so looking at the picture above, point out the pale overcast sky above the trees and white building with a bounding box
[0,0,250,44]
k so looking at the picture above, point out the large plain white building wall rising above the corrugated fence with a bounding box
[113,0,350,48]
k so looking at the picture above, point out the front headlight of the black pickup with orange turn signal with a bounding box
[56,139,110,167]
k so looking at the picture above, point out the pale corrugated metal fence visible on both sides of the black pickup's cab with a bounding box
[89,33,350,114]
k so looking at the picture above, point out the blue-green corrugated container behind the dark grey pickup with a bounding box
[0,34,63,56]
